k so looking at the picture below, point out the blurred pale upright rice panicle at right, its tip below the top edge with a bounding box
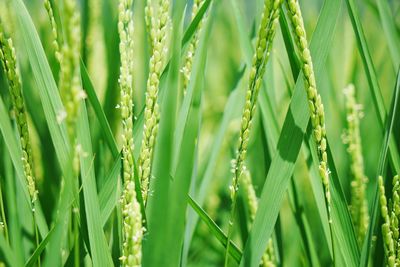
[344,85,369,244]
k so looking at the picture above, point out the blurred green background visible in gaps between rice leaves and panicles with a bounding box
[0,0,400,266]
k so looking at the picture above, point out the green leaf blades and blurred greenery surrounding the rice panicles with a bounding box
[0,0,400,267]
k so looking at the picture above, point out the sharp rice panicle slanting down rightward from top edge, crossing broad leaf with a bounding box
[286,0,332,223]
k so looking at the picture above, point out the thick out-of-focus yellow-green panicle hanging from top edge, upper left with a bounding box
[59,0,85,147]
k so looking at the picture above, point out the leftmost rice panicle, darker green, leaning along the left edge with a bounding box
[0,25,37,202]
